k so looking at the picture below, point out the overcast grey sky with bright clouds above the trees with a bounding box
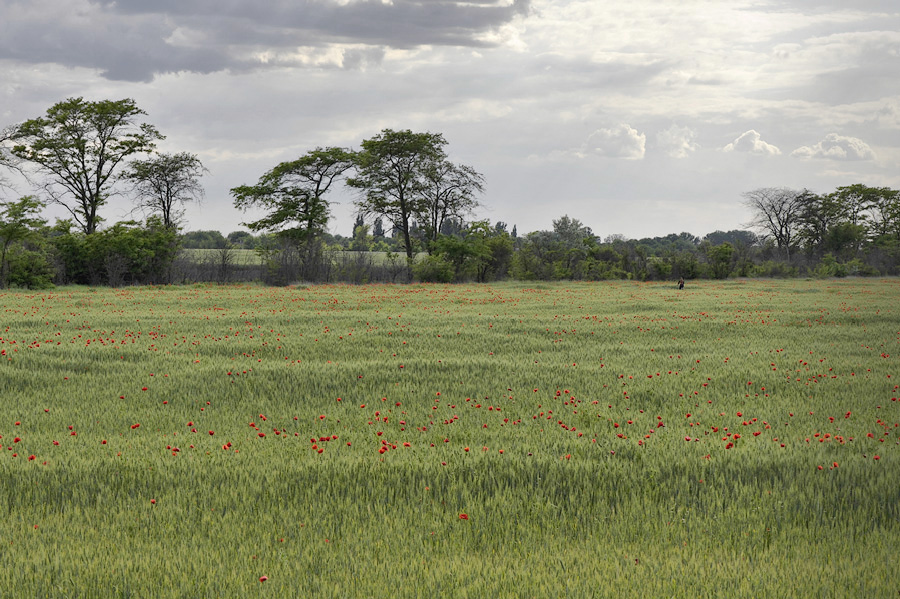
[0,0,900,238]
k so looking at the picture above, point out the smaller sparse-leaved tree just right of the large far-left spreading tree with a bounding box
[122,152,207,228]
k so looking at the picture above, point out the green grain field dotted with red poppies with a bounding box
[0,279,900,598]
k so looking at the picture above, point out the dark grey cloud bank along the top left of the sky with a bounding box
[0,0,529,81]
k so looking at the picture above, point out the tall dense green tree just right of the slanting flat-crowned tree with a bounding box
[347,129,447,274]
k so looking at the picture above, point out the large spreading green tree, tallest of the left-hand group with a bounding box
[12,98,163,234]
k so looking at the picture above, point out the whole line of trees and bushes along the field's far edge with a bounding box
[0,98,900,287]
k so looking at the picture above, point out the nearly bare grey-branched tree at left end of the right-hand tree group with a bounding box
[744,187,810,260]
